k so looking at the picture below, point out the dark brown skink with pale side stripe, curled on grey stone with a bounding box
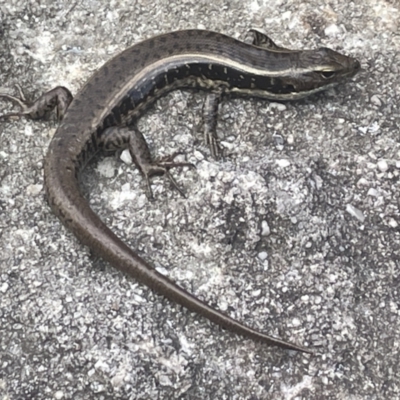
[1,30,360,353]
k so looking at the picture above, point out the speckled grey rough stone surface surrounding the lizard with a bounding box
[0,0,400,400]
